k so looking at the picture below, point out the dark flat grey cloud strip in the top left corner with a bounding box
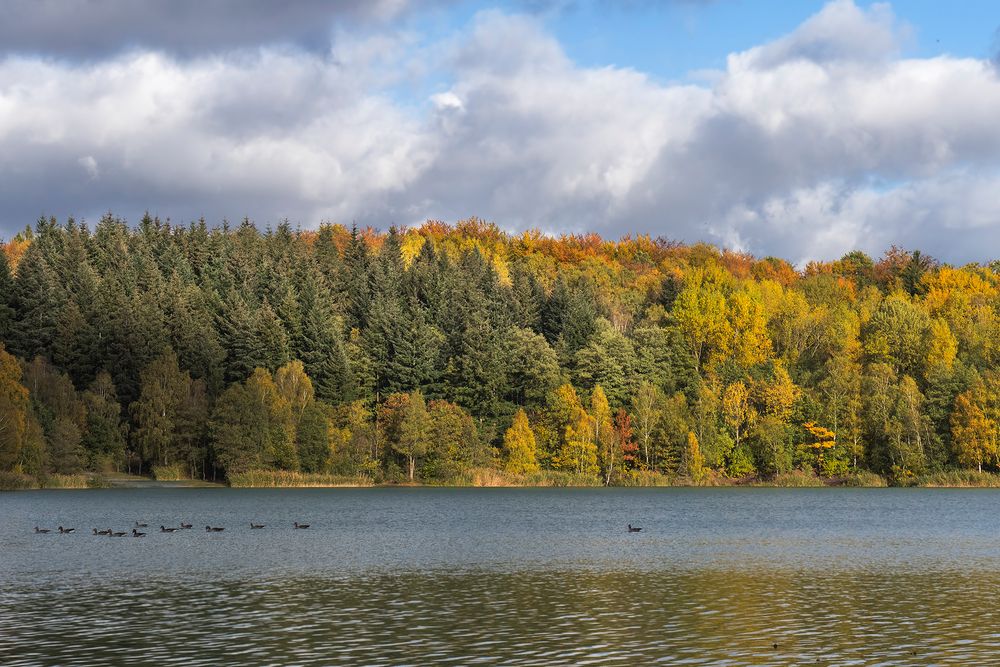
[0,0,426,58]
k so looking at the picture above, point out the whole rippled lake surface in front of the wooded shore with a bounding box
[0,488,1000,665]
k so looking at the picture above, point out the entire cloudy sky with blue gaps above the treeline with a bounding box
[0,0,1000,265]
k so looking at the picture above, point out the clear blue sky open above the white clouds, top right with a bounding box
[414,0,1000,81]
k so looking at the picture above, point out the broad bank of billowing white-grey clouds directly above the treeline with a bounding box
[0,0,1000,262]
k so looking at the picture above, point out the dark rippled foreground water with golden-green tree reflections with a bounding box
[0,570,1000,665]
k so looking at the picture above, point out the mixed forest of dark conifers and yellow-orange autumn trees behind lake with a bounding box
[0,214,1000,485]
